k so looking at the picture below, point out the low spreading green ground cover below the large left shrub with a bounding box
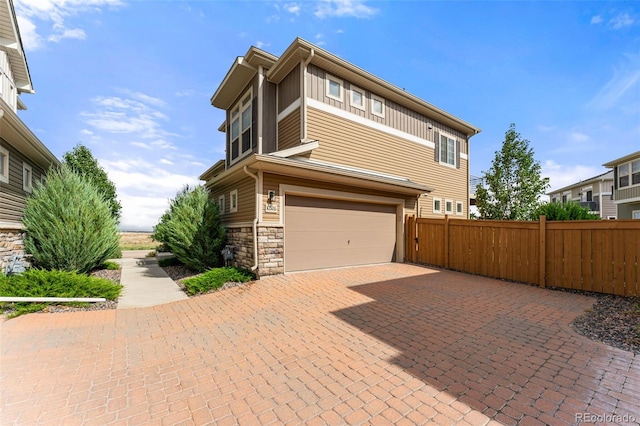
[0,269,122,318]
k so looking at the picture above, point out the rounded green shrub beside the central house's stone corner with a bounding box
[152,186,226,272]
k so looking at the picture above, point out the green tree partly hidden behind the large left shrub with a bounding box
[63,144,122,221]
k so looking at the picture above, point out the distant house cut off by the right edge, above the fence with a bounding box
[604,151,640,219]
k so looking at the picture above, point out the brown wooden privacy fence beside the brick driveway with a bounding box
[405,216,640,296]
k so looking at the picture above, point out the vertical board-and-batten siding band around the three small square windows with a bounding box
[307,65,469,154]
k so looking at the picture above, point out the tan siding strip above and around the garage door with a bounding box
[262,173,416,222]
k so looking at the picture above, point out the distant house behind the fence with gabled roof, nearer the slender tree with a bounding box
[547,171,617,219]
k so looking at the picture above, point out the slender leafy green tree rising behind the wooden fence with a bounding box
[476,123,549,220]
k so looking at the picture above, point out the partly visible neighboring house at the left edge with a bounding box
[0,0,59,270]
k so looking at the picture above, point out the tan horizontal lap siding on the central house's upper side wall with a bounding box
[308,108,469,217]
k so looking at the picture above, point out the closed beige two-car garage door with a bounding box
[284,195,396,272]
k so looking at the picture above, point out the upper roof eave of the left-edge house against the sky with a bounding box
[0,0,35,93]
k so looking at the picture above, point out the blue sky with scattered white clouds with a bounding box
[14,0,640,230]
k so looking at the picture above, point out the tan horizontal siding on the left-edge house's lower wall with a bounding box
[0,139,44,223]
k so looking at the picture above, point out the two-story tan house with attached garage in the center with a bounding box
[200,38,480,276]
